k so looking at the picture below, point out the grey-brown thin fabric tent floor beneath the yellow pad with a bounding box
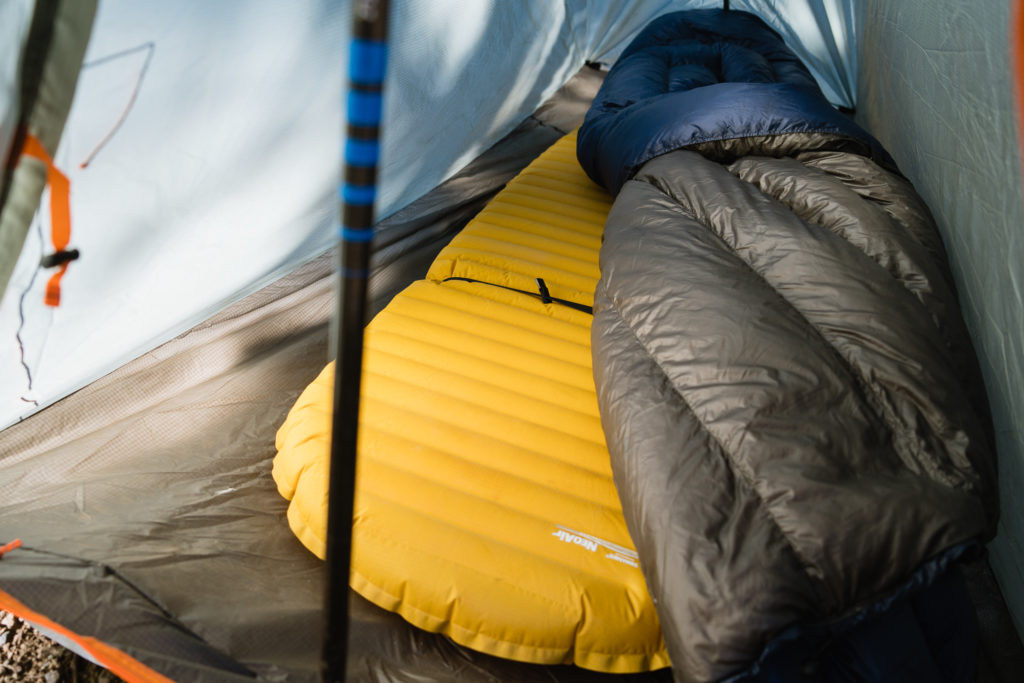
[0,69,1024,683]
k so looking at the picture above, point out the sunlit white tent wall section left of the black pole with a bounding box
[0,0,344,430]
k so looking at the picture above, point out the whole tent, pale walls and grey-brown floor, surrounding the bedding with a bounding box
[0,0,1024,681]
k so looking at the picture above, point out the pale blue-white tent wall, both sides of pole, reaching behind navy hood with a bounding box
[0,0,853,428]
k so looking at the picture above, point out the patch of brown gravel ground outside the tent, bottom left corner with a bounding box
[0,610,121,683]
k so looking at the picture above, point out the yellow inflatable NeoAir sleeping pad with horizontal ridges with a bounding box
[273,135,669,673]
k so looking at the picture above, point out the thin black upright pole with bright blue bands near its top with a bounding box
[322,0,388,683]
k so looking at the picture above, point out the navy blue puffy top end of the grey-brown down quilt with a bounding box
[577,9,895,195]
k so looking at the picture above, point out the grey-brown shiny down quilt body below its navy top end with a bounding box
[581,7,998,681]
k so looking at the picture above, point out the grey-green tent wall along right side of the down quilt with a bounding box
[857,0,1024,632]
